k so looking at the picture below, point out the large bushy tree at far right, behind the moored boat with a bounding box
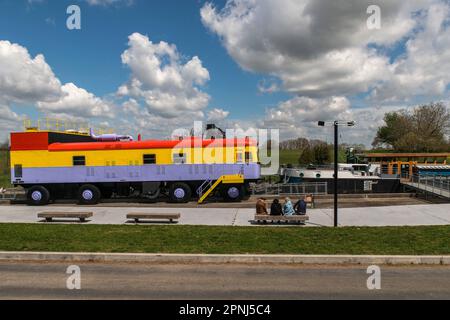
[372,103,450,152]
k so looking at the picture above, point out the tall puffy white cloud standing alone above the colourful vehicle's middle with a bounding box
[117,33,210,118]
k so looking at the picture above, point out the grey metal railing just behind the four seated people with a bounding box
[252,182,328,196]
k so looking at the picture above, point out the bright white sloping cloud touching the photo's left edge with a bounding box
[0,41,113,123]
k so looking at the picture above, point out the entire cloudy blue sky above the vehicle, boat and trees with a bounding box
[0,0,450,145]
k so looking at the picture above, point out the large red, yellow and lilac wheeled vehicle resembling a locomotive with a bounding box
[10,128,260,205]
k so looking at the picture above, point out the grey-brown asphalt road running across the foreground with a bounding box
[0,262,450,300]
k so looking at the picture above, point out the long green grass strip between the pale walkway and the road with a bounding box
[0,224,450,255]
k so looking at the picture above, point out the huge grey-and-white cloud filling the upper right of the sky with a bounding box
[201,0,450,100]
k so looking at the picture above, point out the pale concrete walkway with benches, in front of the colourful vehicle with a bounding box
[0,204,450,226]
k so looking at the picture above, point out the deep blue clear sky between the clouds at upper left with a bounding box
[0,0,287,118]
